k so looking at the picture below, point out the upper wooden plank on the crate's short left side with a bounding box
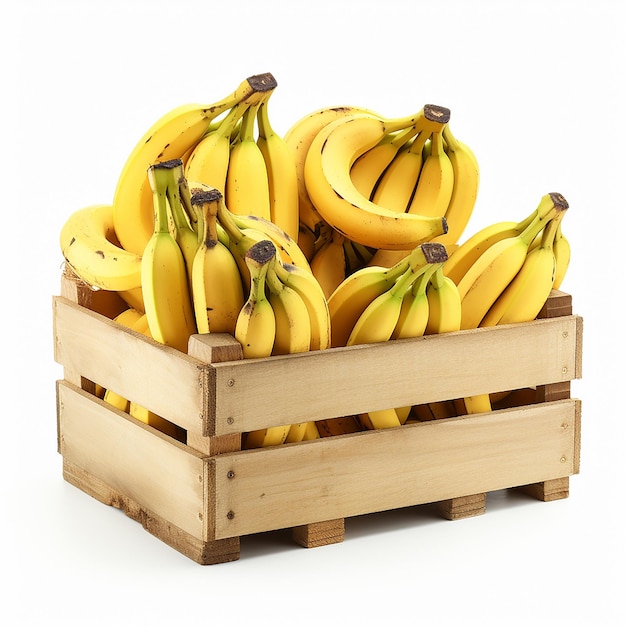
[54,297,208,434]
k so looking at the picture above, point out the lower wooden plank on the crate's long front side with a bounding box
[215,400,578,538]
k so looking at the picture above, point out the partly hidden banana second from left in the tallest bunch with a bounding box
[185,102,250,193]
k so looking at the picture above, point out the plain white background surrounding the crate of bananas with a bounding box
[0,0,626,626]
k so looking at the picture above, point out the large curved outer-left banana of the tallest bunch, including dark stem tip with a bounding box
[113,73,276,255]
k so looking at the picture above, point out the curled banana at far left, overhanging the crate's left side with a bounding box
[60,204,141,291]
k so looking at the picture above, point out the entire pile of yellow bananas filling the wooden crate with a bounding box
[60,73,570,448]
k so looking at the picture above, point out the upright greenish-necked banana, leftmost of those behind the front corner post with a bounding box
[141,159,197,352]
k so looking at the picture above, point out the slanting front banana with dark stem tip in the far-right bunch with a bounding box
[458,193,567,330]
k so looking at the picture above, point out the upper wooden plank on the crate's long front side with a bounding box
[212,316,579,434]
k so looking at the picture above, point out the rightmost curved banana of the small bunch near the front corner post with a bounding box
[274,262,331,350]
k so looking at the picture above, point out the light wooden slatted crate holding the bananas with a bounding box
[53,275,582,564]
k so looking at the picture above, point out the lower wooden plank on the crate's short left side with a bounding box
[57,381,206,540]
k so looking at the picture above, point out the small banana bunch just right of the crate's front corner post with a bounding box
[234,239,330,448]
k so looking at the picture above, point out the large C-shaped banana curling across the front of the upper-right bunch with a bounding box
[305,115,446,250]
